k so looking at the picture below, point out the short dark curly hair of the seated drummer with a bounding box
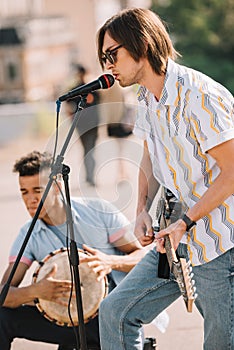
[13,151,52,176]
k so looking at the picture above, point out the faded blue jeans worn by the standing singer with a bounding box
[99,244,234,350]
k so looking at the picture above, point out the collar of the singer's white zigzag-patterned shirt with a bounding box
[137,58,182,106]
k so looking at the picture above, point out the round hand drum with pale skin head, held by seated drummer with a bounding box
[33,248,108,327]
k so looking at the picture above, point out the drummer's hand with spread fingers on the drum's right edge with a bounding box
[80,244,112,281]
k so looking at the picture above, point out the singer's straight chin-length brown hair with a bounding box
[97,8,179,75]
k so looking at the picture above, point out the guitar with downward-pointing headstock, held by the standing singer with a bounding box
[153,191,197,312]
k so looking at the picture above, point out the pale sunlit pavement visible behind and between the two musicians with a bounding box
[0,126,202,350]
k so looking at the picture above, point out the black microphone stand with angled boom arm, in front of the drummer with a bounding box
[0,95,88,350]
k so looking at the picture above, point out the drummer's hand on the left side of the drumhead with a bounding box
[34,264,71,306]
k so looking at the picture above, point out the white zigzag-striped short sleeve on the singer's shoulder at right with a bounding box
[191,84,234,153]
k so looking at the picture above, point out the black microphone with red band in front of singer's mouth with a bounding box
[59,74,115,102]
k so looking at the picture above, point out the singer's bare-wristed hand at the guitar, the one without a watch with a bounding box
[134,210,154,247]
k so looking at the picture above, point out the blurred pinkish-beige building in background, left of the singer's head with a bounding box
[0,0,150,104]
